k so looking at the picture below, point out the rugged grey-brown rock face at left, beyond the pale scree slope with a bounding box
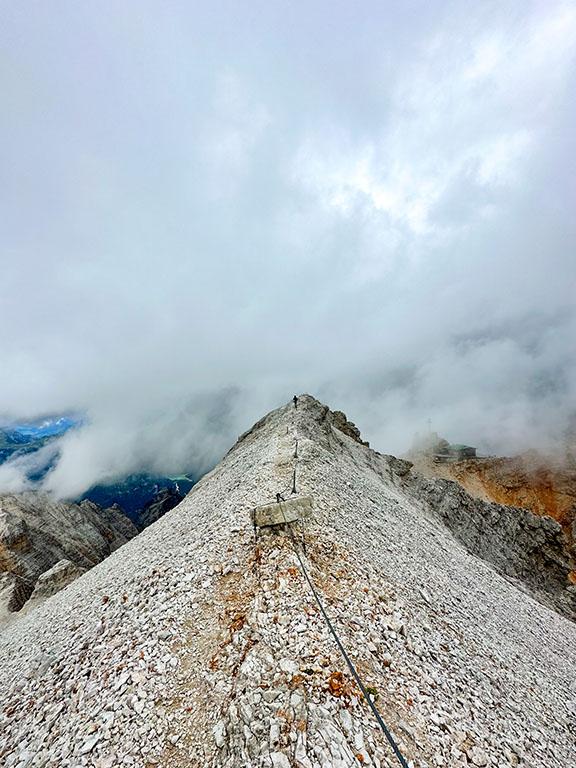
[0,491,138,626]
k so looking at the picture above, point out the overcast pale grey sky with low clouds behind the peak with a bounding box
[0,0,576,495]
